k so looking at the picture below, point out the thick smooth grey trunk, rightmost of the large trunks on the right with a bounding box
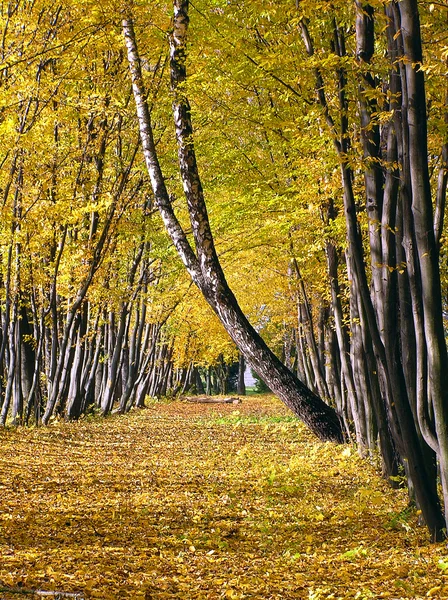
[398,0,448,525]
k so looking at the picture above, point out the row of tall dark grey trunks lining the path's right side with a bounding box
[294,1,448,539]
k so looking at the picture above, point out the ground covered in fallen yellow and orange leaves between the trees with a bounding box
[0,396,448,600]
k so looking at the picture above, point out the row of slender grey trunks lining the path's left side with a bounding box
[0,290,211,425]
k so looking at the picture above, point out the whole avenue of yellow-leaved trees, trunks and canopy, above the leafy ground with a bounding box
[0,0,448,539]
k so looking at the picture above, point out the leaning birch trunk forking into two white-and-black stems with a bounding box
[123,0,344,443]
